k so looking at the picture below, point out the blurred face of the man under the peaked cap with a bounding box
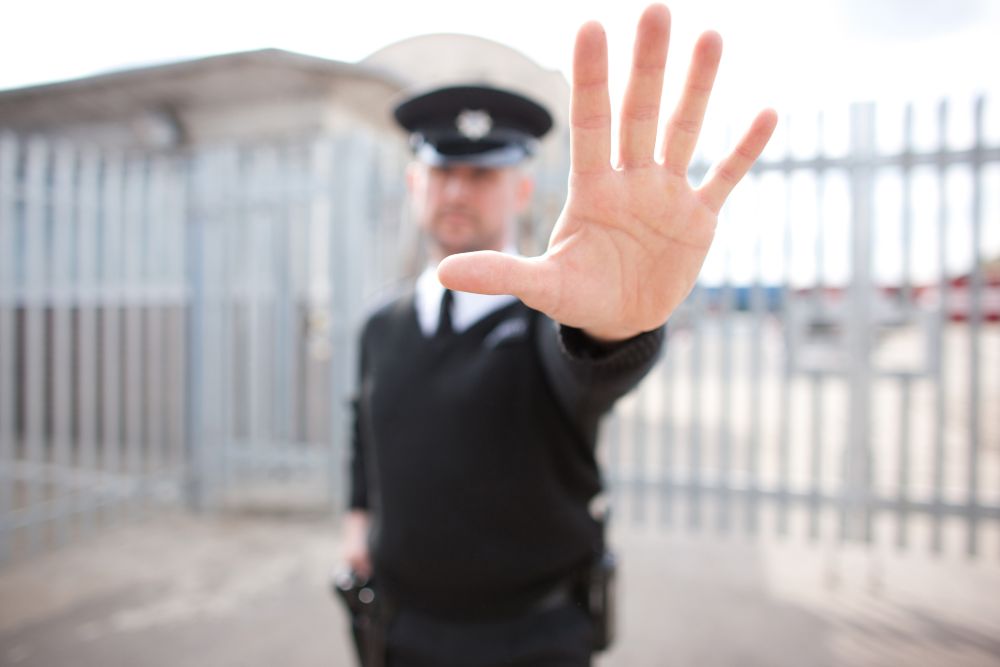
[407,163,532,260]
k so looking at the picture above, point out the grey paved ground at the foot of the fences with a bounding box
[0,515,1000,667]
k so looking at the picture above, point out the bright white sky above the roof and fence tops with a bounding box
[0,0,1000,115]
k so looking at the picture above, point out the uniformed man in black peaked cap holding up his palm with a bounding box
[345,5,775,667]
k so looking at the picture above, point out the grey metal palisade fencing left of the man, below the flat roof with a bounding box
[0,129,414,557]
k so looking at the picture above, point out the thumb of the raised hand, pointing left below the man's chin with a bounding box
[438,250,545,305]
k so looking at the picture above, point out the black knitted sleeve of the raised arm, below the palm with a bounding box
[536,318,666,422]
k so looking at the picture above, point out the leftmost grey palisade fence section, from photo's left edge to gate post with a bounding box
[0,135,189,556]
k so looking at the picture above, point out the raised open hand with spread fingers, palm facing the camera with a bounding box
[438,5,777,341]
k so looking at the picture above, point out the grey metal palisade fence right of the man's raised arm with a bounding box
[607,99,1000,555]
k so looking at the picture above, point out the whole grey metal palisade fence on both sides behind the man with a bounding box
[0,100,1000,559]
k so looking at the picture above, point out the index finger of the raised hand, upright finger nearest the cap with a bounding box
[569,21,611,174]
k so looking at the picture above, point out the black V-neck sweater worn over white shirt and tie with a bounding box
[351,295,663,617]
